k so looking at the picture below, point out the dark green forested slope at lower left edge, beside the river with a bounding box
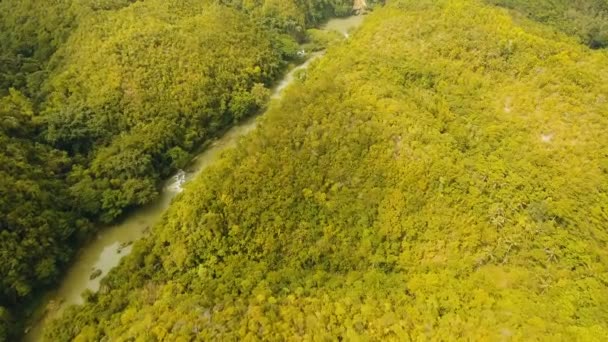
[0,90,91,341]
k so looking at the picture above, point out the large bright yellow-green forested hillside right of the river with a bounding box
[46,0,608,341]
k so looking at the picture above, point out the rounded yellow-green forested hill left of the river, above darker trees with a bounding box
[42,0,281,220]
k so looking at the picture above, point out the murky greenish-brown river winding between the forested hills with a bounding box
[24,16,363,342]
